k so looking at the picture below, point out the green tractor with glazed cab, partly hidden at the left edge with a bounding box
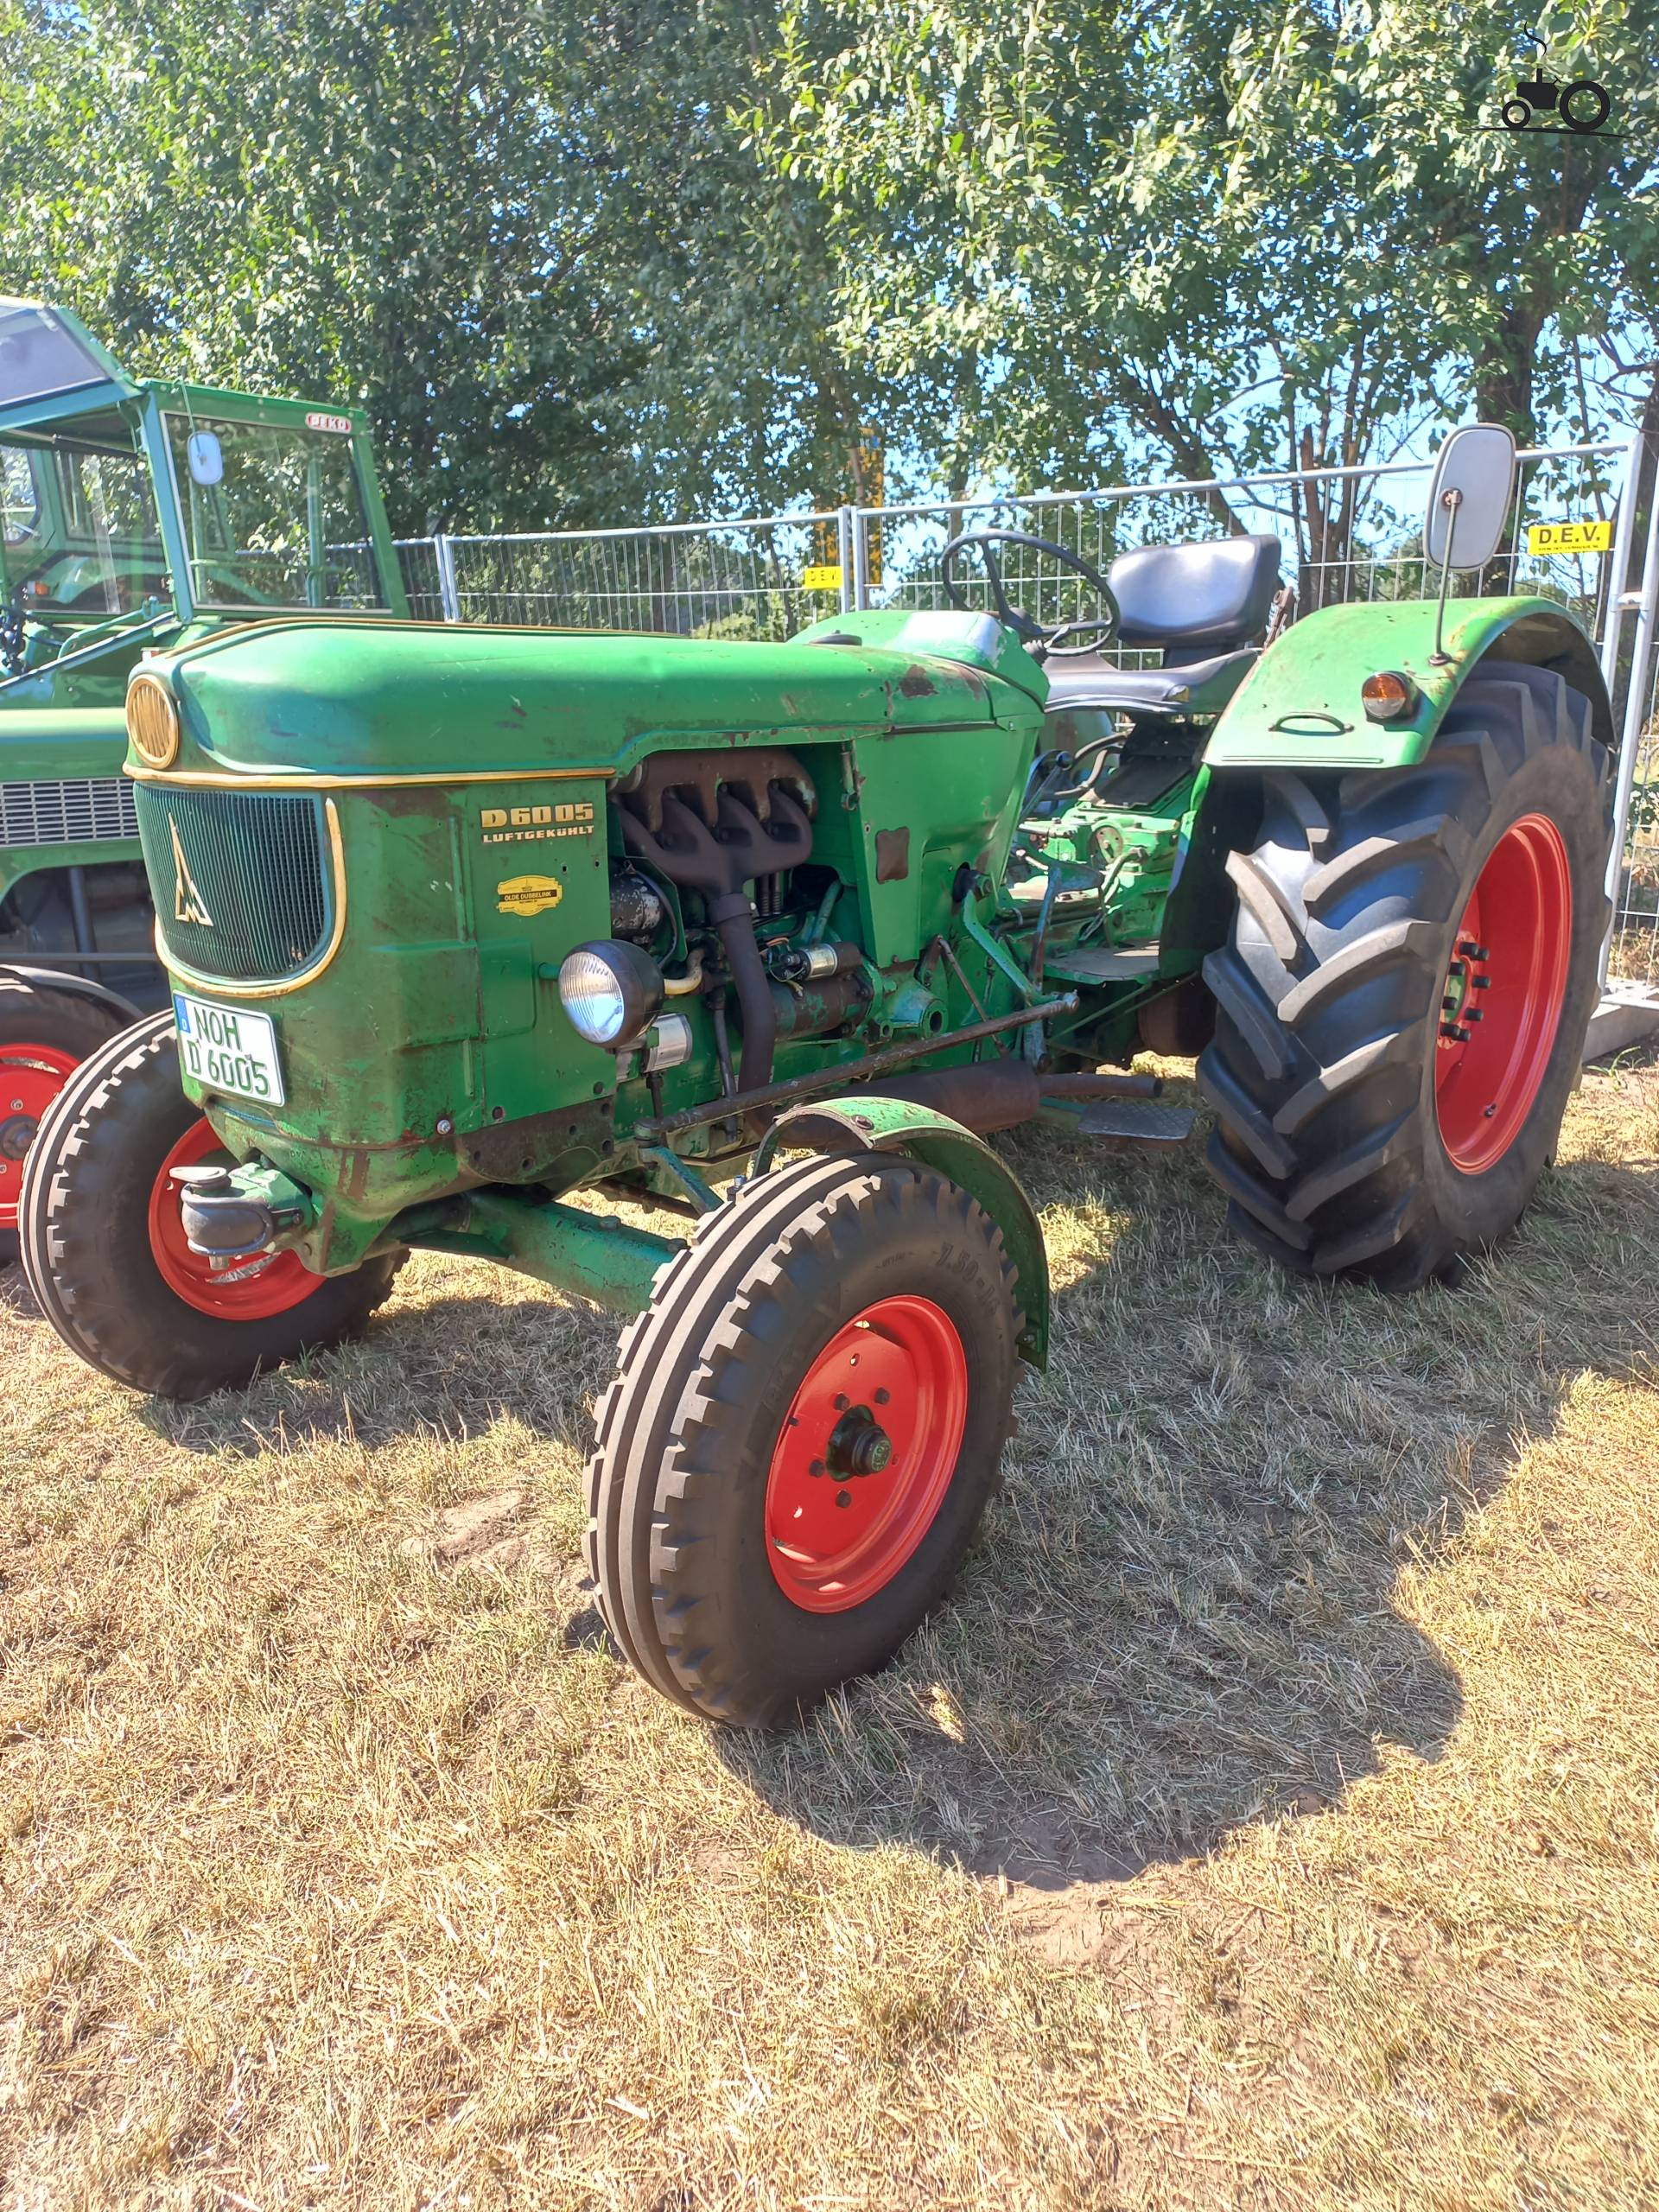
[0,299,407,1261]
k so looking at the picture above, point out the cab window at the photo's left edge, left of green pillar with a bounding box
[0,418,173,621]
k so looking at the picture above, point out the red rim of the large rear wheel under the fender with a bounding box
[1433,814,1573,1174]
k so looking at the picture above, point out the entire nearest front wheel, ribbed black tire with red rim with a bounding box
[588,1154,1020,1727]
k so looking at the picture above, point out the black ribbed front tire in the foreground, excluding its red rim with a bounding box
[588,1154,1020,1727]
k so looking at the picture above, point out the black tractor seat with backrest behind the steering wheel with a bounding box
[1048,536,1281,716]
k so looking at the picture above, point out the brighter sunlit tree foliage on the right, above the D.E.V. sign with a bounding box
[757,0,1659,499]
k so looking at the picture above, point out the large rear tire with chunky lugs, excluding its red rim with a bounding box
[1199,661,1612,1289]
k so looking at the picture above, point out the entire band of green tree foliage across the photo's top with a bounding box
[0,0,1659,531]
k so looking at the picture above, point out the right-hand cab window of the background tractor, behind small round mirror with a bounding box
[168,414,387,613]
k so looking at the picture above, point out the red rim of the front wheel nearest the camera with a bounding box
[766,1296,967,1612]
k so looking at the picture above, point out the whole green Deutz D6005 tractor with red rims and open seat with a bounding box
[22,417,1612,1727]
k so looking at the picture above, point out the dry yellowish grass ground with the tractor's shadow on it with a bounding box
[0,1071,1659,2212]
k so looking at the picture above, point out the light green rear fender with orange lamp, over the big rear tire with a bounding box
[1204,597,1615,767]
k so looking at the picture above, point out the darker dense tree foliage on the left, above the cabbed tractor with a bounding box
[0,0,885,531]
